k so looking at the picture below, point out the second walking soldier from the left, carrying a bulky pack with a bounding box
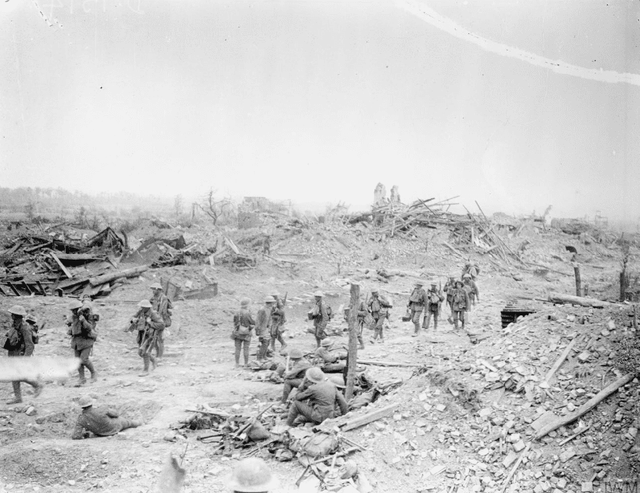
[66,300,98,387]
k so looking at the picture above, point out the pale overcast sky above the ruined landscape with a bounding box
[0,0,640,221]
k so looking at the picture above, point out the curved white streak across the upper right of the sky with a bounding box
[396,0,640,86]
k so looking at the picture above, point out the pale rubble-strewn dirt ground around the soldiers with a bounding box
[0,223,637,493]
